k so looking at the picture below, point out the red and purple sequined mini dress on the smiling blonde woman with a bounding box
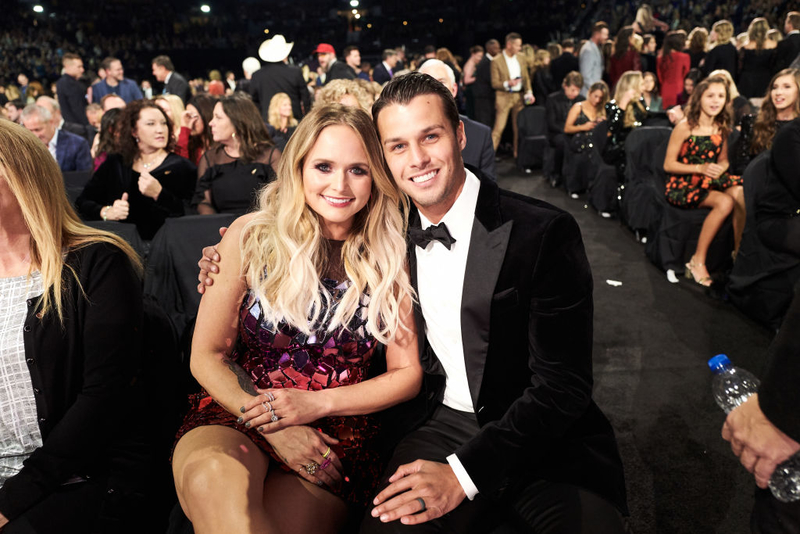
[176,241,383,506]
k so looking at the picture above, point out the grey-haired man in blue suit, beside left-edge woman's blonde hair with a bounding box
[22,104,92,172]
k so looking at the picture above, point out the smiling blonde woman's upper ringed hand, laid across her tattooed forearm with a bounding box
[240,388,329,434]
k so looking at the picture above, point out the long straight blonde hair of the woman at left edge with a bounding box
[0,120,142,323]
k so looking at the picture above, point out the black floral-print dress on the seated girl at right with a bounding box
[666,134,742,208]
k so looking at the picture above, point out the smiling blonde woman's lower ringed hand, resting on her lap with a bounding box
[264,426,344,488]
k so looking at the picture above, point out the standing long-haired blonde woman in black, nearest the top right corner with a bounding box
[738,17,777,100]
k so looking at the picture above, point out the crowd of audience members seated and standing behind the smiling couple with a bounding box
[0,0,800,528]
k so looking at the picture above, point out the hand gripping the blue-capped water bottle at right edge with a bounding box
[722,394,800,488]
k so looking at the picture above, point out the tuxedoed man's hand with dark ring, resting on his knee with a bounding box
[372,460,466,525]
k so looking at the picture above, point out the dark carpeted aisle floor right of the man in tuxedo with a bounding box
[498,159,772,534]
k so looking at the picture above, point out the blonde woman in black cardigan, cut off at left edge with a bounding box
[0,120,147,532]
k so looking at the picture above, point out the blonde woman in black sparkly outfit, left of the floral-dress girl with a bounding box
[603,70,647,181]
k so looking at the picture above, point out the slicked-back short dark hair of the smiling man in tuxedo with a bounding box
[372,72,461,136]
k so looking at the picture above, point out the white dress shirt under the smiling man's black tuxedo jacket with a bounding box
[414,169,481,500]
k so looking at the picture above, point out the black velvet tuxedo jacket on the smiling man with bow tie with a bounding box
[409,169,627,513]
